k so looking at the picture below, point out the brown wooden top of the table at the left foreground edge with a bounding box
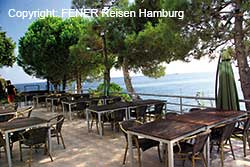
[0,117,48,131]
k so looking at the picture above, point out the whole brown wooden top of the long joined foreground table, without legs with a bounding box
[128,110,246,140]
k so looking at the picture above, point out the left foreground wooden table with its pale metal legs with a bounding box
[0,117,51,167]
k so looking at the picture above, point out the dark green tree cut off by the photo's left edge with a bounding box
[0,27,16,68]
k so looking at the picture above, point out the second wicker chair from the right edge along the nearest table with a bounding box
[210,122,235,167]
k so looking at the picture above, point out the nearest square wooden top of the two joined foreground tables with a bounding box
[128,119,205,140]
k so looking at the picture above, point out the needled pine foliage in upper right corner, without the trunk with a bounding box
[161,0,250,59]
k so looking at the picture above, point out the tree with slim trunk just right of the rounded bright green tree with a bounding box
[69,22,103,93]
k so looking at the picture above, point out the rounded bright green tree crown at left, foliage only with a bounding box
[18,17,93,84]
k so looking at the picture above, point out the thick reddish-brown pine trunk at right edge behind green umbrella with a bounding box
[234,0,250,110]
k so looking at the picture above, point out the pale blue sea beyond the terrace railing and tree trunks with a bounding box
[15,72,244,111]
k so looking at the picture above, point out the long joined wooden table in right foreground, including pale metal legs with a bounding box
[128,110,247,167]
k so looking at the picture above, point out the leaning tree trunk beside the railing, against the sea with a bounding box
[122,58,140,100]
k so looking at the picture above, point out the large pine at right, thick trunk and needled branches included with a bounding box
[162,0,250,110]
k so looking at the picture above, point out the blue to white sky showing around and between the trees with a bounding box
[0,0,217,84]
